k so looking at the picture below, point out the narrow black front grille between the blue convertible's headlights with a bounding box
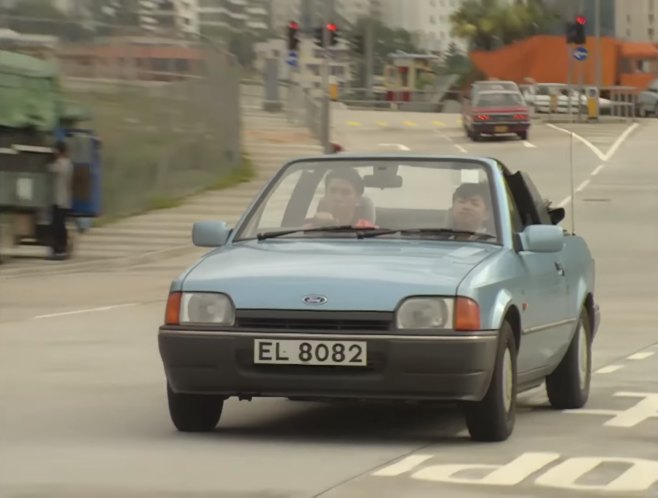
[236,310,393,332]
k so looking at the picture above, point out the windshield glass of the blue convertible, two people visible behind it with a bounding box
[234,158,499,243]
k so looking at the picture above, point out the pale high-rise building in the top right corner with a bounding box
[615,0,658,43]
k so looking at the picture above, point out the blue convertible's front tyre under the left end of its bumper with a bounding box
[167,383,224,432]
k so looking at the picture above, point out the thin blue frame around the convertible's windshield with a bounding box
[227,154,507,245]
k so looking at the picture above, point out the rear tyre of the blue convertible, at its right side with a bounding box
[546,309,592,410]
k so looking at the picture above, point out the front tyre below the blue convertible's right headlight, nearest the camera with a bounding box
[463,321,517,442]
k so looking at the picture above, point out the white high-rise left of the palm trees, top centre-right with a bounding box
[380,0,466,52]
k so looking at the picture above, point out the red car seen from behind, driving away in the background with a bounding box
[462,90,530,141]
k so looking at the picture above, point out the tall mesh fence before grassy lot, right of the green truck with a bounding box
[0,16,241,215]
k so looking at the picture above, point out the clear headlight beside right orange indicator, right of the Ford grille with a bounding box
[396,297,454,329]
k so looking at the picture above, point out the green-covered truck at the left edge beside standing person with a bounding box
[0,51,100,263]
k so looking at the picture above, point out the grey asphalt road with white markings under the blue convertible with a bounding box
[0,114,658,498]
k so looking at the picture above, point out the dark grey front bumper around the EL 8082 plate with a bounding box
[158,326,498,401]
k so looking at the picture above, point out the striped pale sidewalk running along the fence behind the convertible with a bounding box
[0,100,322,279]
